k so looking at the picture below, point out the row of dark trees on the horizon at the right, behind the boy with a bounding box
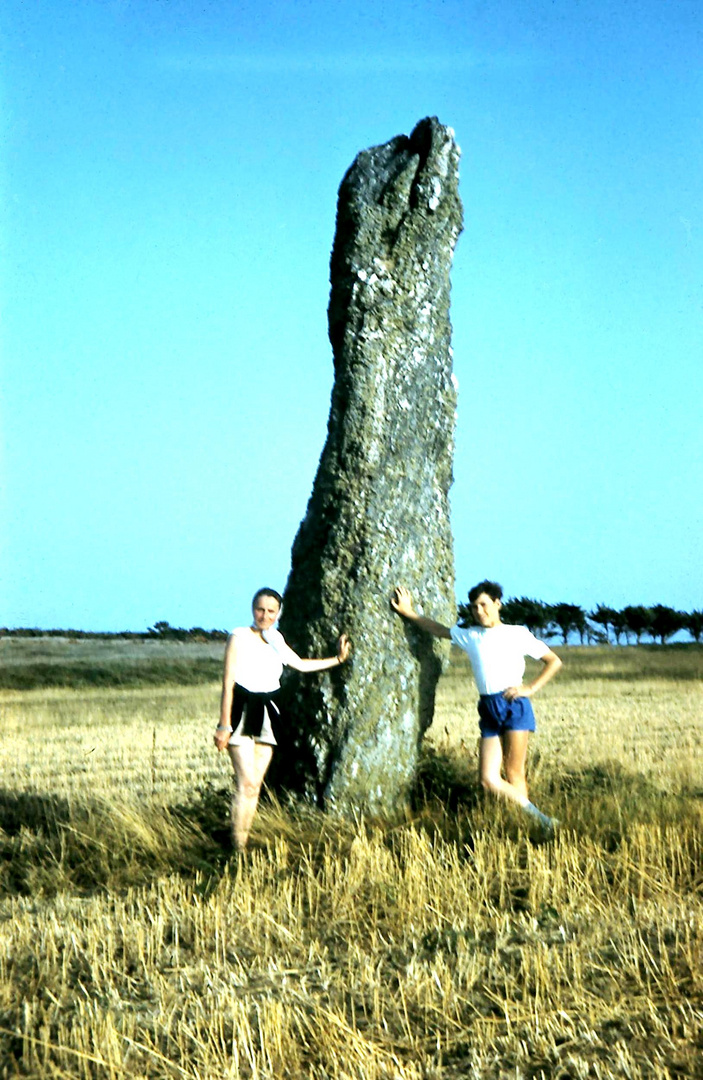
[459,596,703,645]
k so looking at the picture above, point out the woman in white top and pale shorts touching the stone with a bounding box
[215,589,350,851]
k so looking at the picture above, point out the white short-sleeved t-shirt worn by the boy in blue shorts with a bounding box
[450,622,550,694]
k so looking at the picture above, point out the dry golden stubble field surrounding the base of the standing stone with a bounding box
[0,642,703,1080]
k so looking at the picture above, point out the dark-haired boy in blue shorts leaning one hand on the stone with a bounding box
[391,581,562,835]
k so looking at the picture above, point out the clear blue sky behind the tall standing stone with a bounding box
[0,0,703,630]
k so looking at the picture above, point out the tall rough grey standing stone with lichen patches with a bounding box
[276,118,462,813]
